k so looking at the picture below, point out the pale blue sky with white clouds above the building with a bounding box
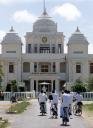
[0,0,93,54]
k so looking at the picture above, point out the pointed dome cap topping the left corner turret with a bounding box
[2,27,21,43]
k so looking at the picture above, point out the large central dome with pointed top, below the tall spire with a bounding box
[33,11,57,32]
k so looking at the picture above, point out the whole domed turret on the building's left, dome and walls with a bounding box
[1,27,22,57]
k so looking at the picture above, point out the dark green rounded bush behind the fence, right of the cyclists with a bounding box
[71,79,86,92]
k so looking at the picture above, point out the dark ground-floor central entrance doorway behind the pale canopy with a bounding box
[38,80,52,92]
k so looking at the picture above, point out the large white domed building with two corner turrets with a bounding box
[0,10,93,92]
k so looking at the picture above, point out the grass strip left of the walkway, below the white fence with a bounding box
[8,101,30,114]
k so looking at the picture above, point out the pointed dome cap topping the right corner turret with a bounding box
[68,27,88,44]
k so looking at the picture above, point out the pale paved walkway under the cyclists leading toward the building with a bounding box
[1,100,90,128]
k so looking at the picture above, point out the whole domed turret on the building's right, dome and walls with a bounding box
[68,27,88,55]
